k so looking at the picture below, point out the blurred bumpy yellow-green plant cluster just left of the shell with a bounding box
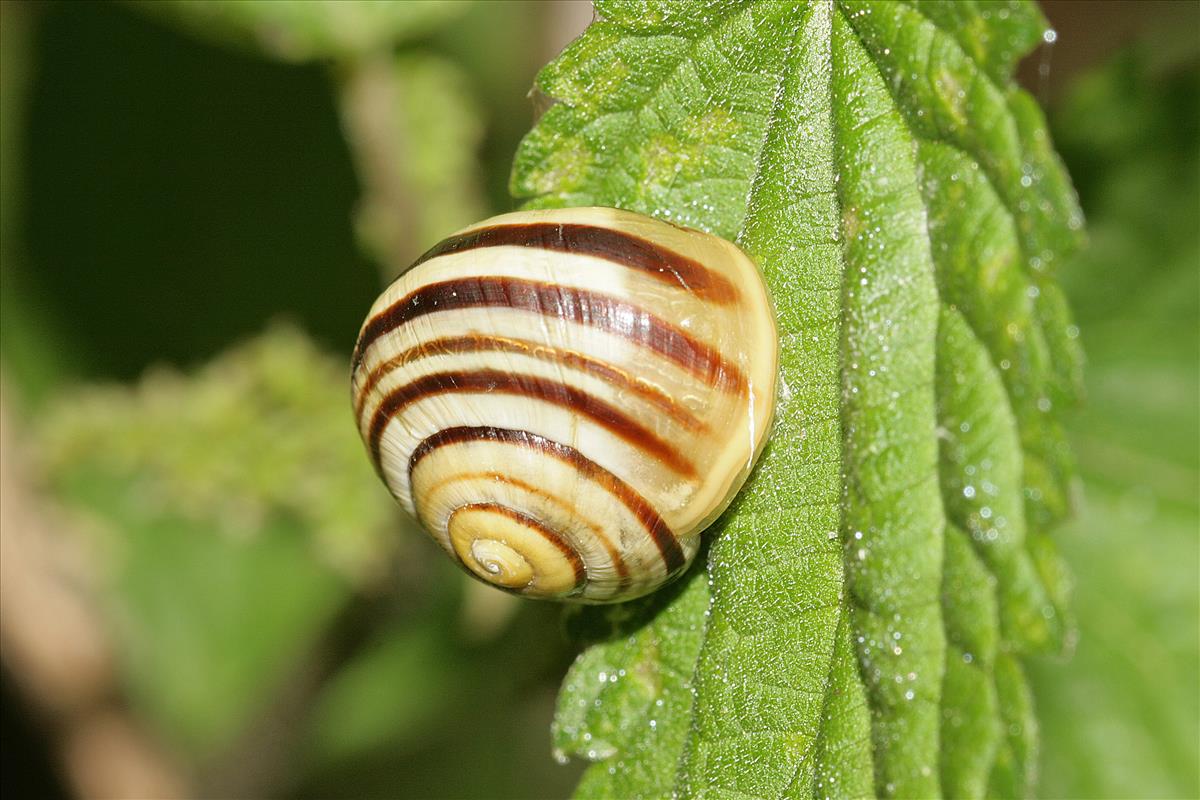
[41,326,392,581]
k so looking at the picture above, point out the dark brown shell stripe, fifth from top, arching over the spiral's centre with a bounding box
[408,426,686,576]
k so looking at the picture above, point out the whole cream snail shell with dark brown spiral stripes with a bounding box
[353,209,778,602]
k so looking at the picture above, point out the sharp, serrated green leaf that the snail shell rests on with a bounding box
[512,0,1081,798]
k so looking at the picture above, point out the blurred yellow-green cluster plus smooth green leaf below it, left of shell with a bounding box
[38,327,394,758]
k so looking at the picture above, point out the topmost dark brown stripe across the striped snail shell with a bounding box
[413,222,738,306]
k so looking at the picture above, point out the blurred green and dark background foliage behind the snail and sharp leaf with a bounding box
[0,0,1200,798]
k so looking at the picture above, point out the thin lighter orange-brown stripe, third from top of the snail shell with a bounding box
[354,335,708,433]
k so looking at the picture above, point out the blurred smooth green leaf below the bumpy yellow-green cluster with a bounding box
[96,501,347,763]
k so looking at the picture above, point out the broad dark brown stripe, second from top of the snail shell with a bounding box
[354,276,748,395]
